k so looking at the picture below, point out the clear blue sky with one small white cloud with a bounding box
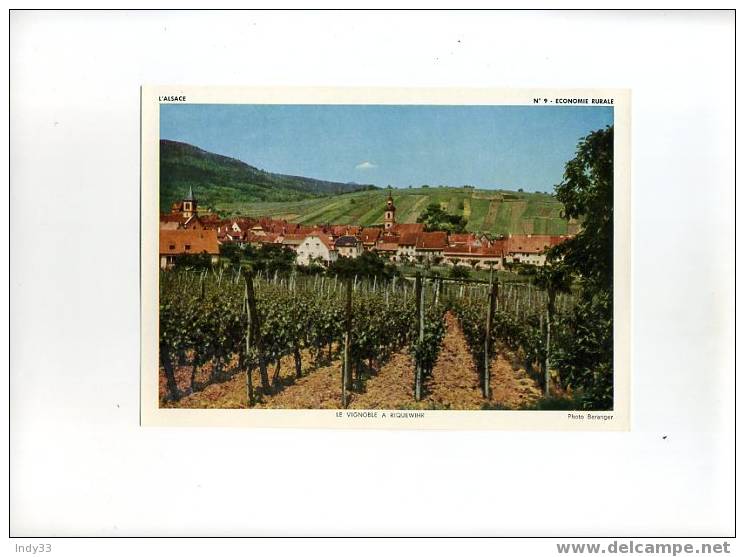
[160,104,613,191]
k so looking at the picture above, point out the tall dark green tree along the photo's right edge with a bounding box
[548,126,613,410]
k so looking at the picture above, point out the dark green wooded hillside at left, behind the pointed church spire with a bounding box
[160,139,372,212]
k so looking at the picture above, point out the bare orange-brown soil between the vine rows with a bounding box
[160,313,541,410]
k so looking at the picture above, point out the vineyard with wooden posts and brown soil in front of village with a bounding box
[160,269,574,410]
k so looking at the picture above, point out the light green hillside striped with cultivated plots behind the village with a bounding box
[240,187,577,234]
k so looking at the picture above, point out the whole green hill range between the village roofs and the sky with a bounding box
[160,140,577,234]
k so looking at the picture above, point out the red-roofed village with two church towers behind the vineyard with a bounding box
[159,188,571,270]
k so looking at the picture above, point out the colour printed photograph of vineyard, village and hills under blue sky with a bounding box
[158,99,614,412]
